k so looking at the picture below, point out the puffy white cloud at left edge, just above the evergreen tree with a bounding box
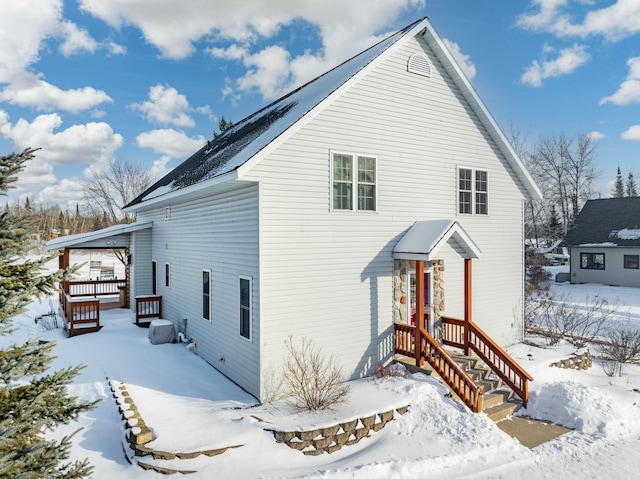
[0,110,124,172]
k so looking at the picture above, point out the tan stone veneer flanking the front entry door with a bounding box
[393,259,445,340]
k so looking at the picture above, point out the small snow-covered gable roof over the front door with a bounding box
[393,220,480,261]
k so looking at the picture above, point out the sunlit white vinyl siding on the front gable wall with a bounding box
[245,34,525,402]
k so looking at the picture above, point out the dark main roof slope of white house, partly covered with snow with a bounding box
[127,19,425,207]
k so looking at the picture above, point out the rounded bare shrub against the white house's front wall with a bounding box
[284,336,351,411]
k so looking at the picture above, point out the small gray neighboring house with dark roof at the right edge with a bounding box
[563,197,640,288]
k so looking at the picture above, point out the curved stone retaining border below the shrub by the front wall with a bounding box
[269,406,409,456]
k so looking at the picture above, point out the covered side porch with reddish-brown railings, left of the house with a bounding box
[45,223,162,337]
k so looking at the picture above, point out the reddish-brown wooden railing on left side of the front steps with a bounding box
[395,323,483,412]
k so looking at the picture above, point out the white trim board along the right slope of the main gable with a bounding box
[425,19,542,200]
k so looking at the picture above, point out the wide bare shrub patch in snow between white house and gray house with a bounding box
[525,291,618,346]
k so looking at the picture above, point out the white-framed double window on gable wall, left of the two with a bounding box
[331,152,378,211]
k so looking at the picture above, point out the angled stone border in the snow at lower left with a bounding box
[109,380,243,474]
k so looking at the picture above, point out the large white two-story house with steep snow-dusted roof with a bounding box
[50,19,540,399]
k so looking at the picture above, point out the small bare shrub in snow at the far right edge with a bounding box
[598,320,640,376]
